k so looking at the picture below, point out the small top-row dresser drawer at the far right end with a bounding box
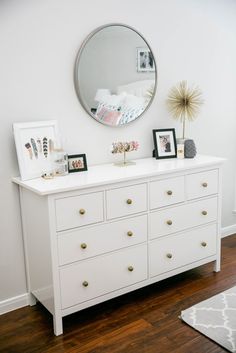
[186,170,218,200]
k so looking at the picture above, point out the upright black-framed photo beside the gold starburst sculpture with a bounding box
[153,129,177,159]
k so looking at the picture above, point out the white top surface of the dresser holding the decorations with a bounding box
[12,155,224,195]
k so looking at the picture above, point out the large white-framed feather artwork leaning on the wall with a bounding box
[13,120,59,180]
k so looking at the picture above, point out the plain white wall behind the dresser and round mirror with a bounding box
[0,0,236,301]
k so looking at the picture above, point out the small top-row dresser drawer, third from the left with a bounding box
[150,177,184,209]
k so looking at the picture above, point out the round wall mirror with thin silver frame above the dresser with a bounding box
[74,24,157,126]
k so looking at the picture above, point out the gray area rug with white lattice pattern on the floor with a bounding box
[181,286,236,352]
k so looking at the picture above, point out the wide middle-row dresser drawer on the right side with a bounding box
[150,197,217,238]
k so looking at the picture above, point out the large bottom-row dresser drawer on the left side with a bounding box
[60,245,147,309]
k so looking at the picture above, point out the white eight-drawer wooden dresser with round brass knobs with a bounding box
[13,156,223,335]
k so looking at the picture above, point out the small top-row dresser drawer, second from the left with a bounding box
[106,184,147,219]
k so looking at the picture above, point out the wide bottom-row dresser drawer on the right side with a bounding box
[149,224,217,277]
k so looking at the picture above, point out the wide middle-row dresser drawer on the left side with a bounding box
[58,215,147,265]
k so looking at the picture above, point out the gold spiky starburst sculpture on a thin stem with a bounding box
[167,81,203,139]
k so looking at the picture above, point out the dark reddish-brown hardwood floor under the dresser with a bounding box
[0,235,236,353]
